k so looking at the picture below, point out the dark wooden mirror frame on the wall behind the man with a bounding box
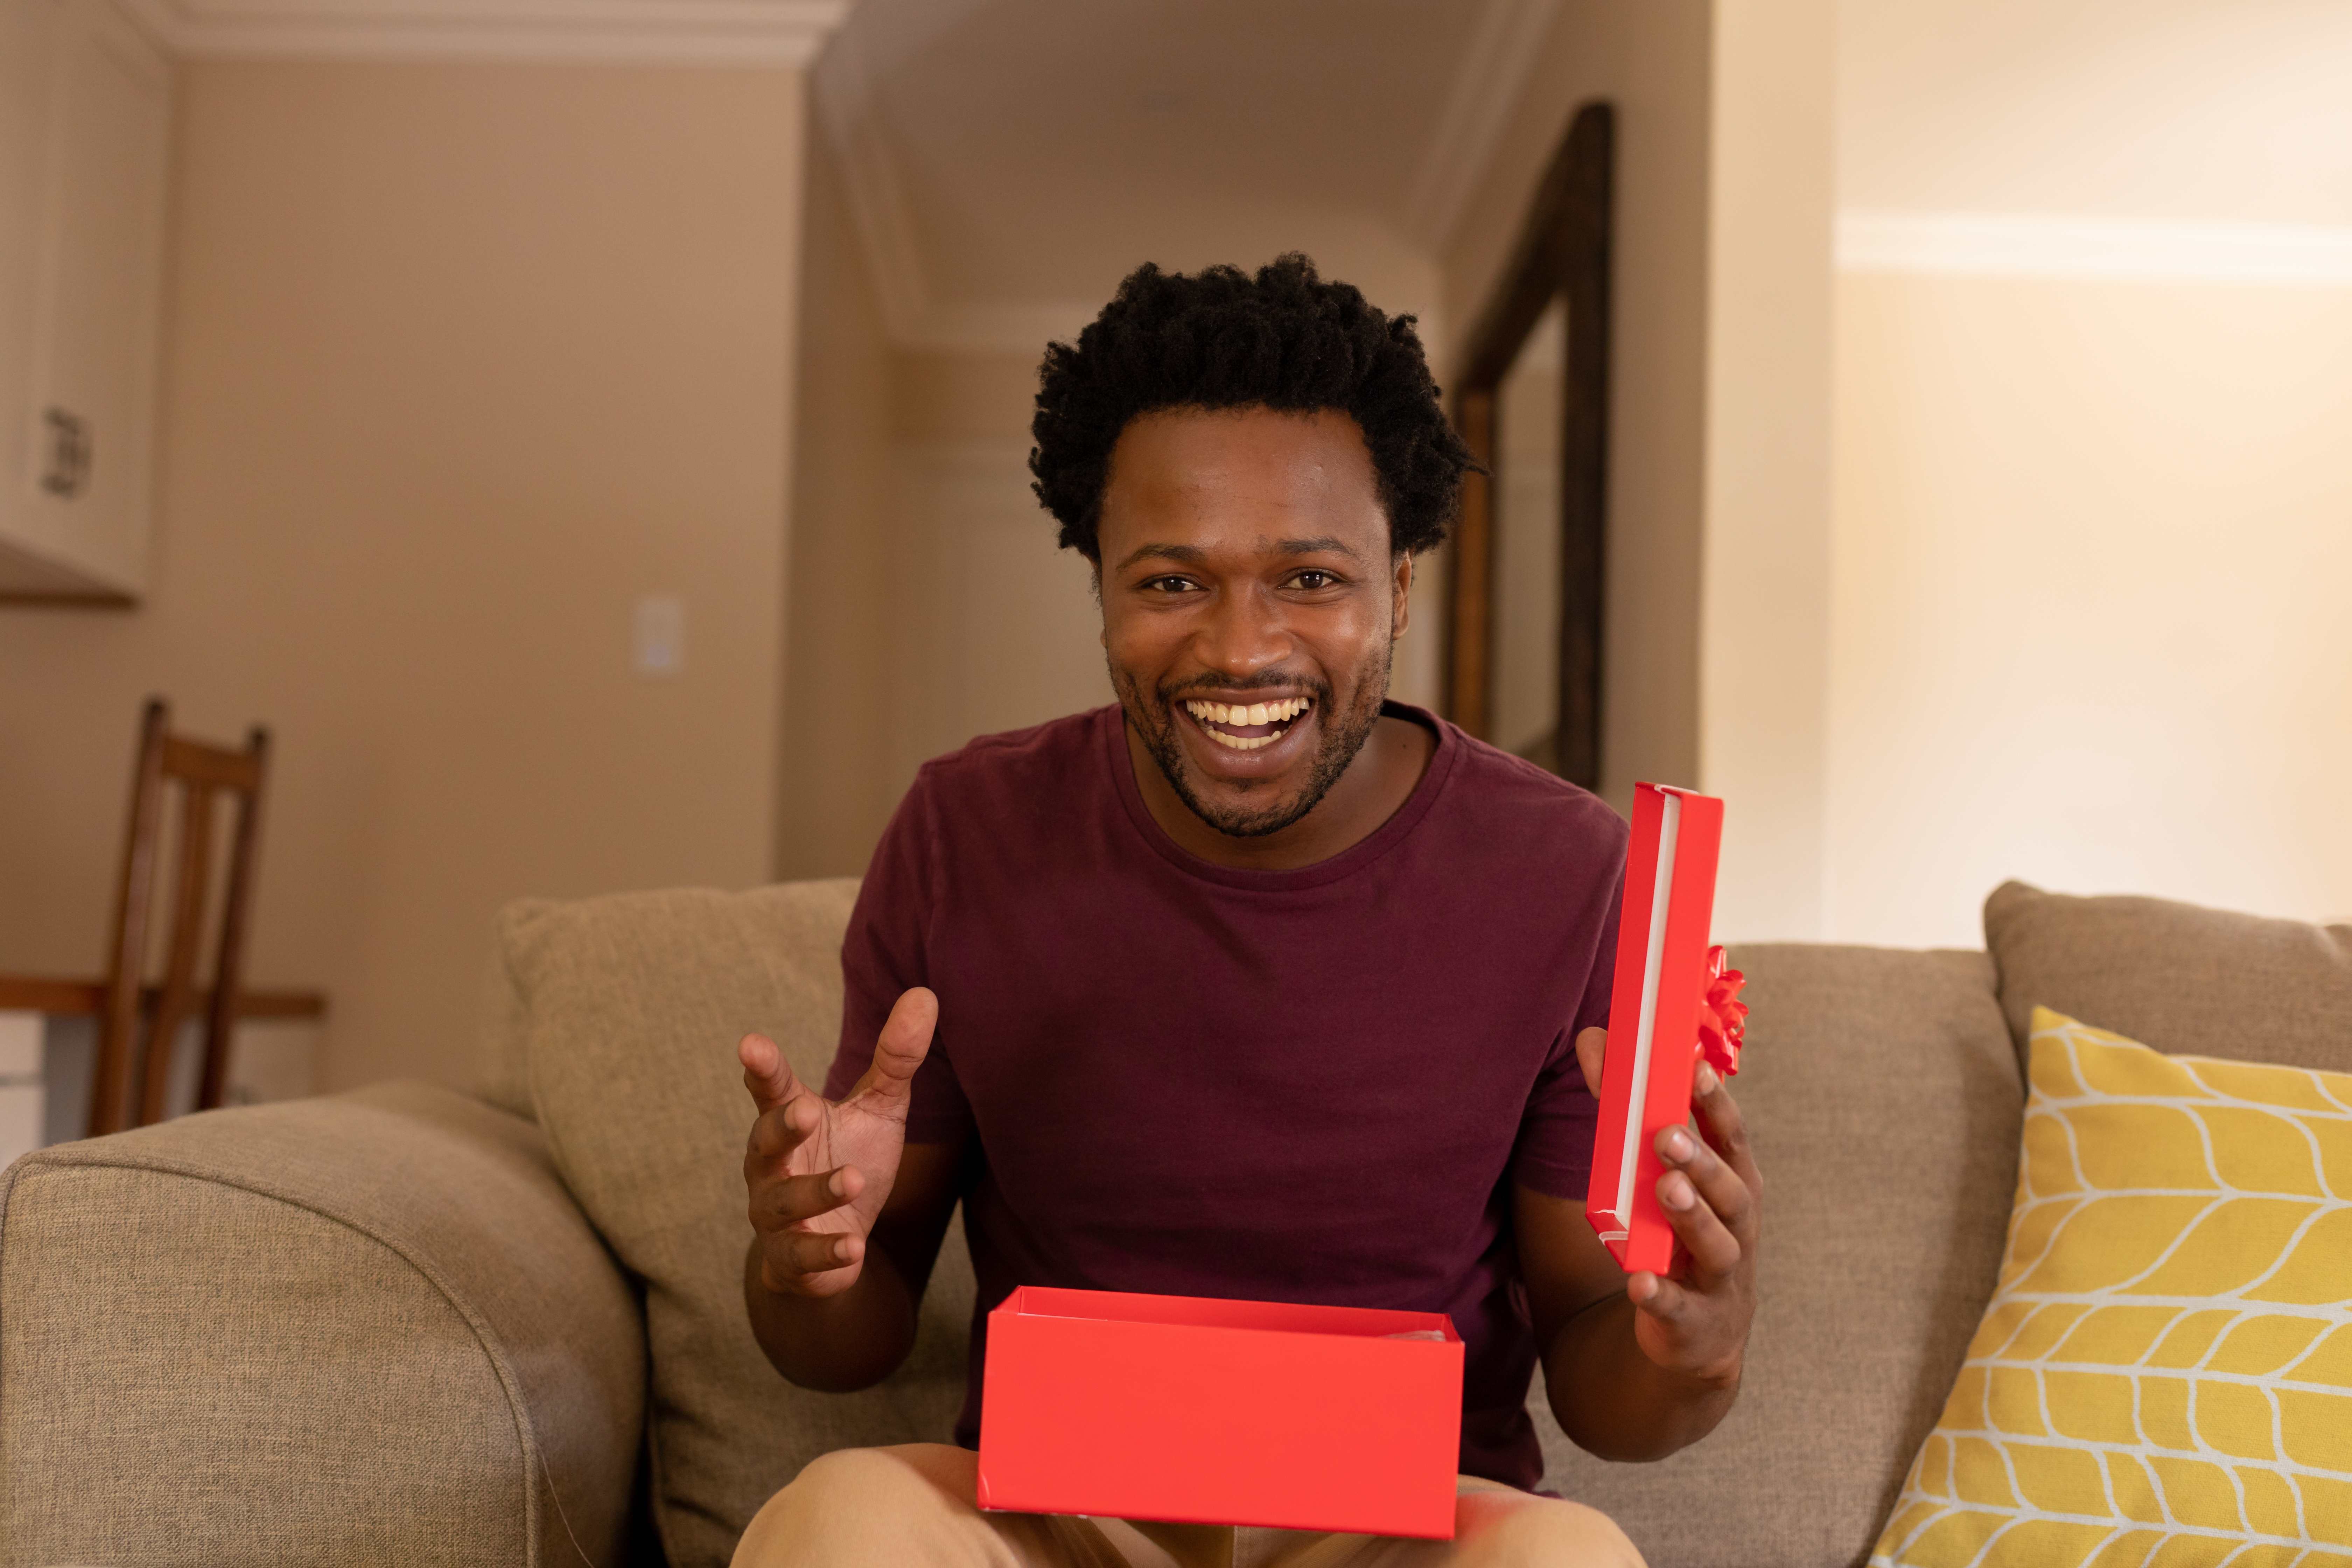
[1447,104,1616,790]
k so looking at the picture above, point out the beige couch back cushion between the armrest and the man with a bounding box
[501,882,971,1568]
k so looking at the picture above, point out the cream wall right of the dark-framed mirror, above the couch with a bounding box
[1447,0,2352,943]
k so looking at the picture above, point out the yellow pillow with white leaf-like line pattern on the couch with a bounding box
[1870,1008,2352,1568]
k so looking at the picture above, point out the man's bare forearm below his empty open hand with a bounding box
[743,1142,964,1394]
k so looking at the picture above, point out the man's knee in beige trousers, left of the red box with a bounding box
[734,1443,974,1568]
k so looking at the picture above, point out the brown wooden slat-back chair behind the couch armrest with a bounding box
[89,698,271,1138]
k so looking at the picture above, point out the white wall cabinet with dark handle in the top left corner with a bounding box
[0,0,172,602]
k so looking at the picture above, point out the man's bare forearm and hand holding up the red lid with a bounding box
[1512,1030,1764,1460]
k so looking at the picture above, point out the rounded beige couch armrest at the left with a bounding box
[0,1084,644,1563]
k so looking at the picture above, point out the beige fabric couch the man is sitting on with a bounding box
[0,884,2352,1568]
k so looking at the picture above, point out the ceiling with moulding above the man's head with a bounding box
[816,0,1559,350]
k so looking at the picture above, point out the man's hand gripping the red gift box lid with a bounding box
[1576,1030,1764,1382]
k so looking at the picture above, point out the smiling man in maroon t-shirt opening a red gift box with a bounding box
[736,256,1759,1568]
